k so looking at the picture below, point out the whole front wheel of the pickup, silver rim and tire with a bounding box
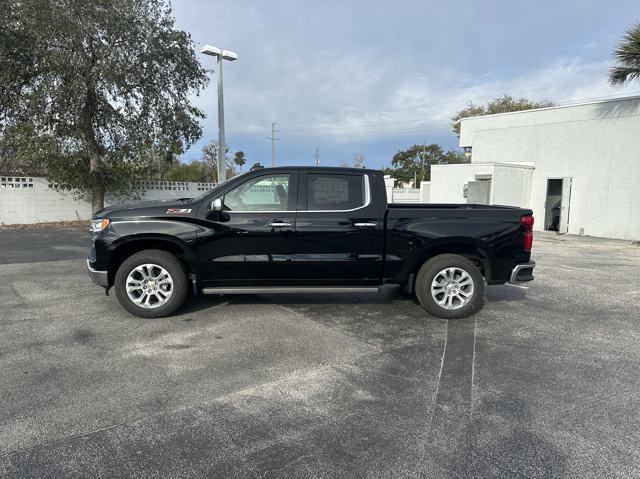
[114,249,188,318]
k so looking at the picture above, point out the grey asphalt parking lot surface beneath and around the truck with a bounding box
[0,230,640,478]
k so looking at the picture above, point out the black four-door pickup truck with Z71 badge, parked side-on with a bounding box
[87,167,535,319]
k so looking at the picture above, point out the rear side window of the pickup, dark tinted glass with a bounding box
[307,173,365,210]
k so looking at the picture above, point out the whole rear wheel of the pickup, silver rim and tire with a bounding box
[415,254,484,319]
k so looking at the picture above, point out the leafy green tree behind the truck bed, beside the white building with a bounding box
[385,143,466,186]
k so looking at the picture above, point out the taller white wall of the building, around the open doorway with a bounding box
[460,97,640,240]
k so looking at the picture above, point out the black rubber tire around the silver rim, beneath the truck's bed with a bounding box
[415,254,484,319]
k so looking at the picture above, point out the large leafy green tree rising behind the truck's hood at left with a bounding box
[0,0,208,211]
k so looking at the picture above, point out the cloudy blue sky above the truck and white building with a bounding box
[173,0,640,168]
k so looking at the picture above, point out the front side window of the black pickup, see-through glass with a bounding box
[224,175,290,211]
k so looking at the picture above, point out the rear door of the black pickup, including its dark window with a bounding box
[295,170,386,285]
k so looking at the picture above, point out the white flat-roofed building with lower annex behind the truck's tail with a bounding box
[429,96,640,240]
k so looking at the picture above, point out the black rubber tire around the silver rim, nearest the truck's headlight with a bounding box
[114,249,189,318]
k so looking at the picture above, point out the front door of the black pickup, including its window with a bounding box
[197,172,298,286]
